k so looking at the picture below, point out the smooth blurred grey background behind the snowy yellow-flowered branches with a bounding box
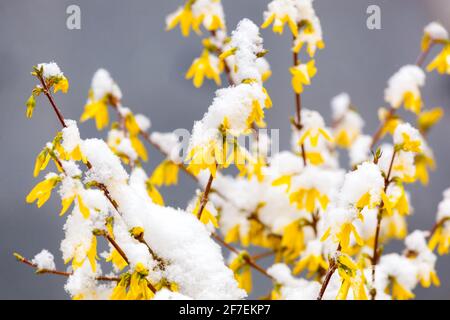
[0,0,450,299]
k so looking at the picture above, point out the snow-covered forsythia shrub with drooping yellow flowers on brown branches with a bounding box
[15,0,450,299]
